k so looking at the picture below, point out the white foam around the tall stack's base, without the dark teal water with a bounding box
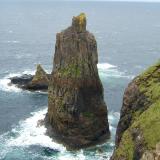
[0,108,119,160]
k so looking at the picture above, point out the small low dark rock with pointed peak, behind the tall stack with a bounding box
[10,64,50,91]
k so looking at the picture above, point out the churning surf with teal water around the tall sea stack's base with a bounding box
[0,108,119,160]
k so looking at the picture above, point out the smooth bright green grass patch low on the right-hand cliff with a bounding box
[132,100,160,150]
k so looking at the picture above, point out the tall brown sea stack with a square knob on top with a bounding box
[46,14,110,149]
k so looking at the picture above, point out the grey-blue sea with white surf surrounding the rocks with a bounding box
[0,0,160,160]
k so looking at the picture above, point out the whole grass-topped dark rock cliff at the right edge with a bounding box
[111,61,160,160]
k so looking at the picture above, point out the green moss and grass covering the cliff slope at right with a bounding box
[112,61,160,160]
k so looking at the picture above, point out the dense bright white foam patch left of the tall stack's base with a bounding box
[7,109,65,151]
